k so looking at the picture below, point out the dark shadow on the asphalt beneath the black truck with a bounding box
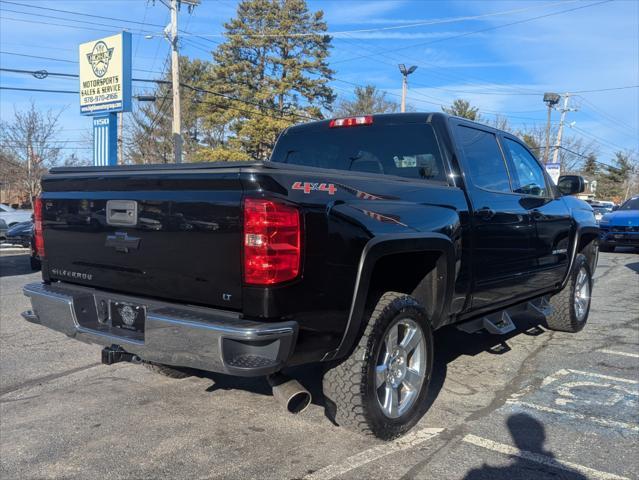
[192,313,546,423]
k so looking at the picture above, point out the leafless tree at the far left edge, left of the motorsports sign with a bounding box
[0,101,64,207]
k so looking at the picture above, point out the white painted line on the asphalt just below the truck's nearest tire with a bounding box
[304,428,444,480]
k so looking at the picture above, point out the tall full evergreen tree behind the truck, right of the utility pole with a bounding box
[198,0,334,160]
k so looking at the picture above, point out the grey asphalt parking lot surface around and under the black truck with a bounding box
[0,251,639,480]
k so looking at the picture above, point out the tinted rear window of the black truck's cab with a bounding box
[271,123,446,181]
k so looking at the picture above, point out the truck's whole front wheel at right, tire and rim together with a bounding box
[546,253,592,333]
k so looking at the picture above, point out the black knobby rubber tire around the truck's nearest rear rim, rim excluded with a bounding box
[323,292,433,440]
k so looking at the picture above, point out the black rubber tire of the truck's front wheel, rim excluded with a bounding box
[546,253,592,333]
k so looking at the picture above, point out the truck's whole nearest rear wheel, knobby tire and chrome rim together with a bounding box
[323,292,433,440]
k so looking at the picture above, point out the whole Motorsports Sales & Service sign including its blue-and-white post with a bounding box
[79,32,131,166]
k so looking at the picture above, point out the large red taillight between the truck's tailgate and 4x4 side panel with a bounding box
[244,198,300,285]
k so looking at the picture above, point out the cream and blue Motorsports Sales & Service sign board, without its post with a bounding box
[80,32,131,115]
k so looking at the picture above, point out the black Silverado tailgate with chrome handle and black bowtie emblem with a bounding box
[42,167,242,310]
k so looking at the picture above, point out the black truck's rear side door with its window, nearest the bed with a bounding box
[452,120,536,310]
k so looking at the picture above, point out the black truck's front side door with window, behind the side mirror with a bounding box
[501,135,572,289]
